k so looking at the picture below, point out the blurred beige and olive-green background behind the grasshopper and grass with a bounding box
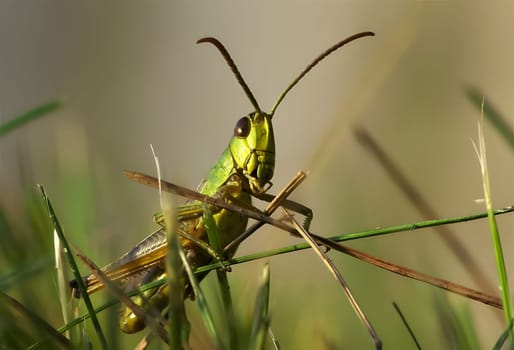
[0,0,514,349]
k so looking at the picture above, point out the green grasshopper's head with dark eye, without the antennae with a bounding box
[229,111,275,193]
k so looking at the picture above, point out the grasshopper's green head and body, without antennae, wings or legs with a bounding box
[117,112,275,333]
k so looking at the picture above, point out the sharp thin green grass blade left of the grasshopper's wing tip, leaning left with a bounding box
[38,185,109,349]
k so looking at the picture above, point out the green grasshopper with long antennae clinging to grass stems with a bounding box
[71,32,374,333]
